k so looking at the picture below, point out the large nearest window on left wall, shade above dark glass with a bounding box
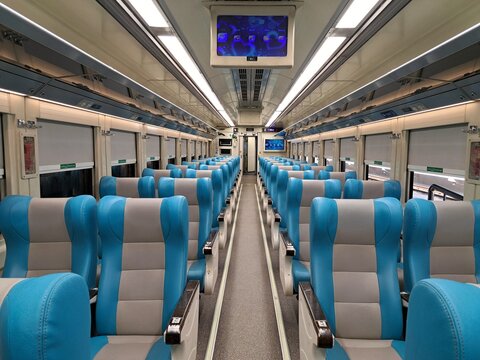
[38,120,94,197]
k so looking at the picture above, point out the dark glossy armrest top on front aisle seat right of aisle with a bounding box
[298,282,335,349]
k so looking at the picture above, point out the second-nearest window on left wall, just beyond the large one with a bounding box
[110,130,137,177]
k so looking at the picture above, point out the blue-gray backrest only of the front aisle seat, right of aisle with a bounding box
[310,198,403,339]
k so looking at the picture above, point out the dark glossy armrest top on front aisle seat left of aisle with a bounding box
[164,280,200,345]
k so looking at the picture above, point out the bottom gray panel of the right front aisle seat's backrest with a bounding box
[335,302,382,339]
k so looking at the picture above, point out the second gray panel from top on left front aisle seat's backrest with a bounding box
[122,242,165,270]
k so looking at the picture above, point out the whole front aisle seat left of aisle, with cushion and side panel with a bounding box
[90,195,199,360]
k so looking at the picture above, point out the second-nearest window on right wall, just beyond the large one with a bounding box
[365,134,392,181]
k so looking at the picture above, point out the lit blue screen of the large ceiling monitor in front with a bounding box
[217,15,288,57]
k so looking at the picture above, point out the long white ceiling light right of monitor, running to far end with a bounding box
[266,36,346,127]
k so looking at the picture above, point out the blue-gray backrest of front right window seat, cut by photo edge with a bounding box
[403,199,480,291]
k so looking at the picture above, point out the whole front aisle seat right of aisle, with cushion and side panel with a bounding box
[299,198,405,360]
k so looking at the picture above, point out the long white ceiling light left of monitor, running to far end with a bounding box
[158,35,235,126]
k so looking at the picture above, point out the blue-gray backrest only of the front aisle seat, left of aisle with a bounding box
[96,195,188,335]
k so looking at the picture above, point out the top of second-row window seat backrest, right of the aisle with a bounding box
[343,179,402,200]
